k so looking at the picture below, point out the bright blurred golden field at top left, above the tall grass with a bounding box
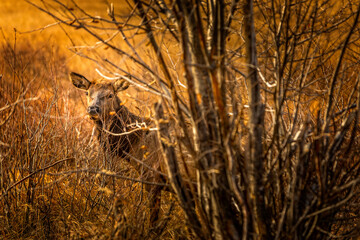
[0,0,135,74]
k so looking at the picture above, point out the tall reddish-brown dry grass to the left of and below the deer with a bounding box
[0,33,188,239]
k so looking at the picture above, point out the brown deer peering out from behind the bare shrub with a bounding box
[69,72,166,225]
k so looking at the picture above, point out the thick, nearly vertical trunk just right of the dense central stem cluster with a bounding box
[243,0,267,239]
